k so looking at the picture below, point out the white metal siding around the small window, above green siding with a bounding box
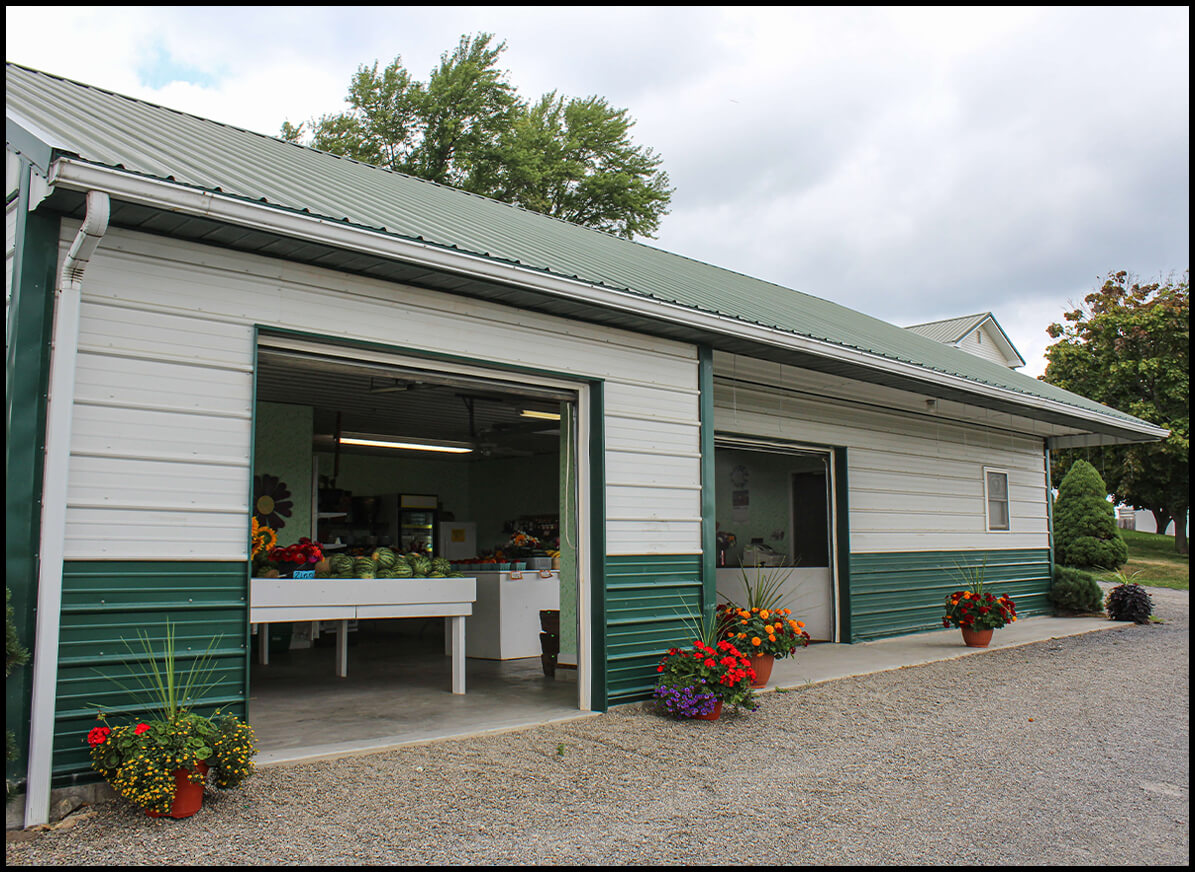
[715,355,1049,552]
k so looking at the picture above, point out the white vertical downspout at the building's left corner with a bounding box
[25,190,110,827]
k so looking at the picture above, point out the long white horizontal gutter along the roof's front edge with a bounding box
[50,158,1170,438]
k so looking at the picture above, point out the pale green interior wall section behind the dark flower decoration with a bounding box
[253,403,313,545]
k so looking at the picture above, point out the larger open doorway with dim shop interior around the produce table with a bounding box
[250,334,590,759]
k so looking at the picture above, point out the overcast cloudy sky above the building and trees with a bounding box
[5,6,1190,375]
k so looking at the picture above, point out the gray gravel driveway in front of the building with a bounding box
[7,590,1190,866]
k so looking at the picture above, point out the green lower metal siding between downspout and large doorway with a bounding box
[54,561,249,784]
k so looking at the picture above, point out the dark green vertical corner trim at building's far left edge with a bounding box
[5,172,60,781]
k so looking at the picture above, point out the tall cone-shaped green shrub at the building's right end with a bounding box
[1054,460,1128,570]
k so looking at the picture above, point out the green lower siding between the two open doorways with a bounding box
[605,554,705,705]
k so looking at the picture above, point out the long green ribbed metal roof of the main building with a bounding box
[6,63,1156,429]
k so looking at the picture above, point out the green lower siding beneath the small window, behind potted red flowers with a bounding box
[848,548,1050,641]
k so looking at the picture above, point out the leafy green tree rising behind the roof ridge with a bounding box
[282,33,672,239]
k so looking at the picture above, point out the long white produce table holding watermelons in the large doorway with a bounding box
[249,578,477,693]
